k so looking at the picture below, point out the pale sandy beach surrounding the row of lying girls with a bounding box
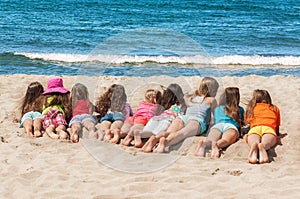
[0,75,300,199]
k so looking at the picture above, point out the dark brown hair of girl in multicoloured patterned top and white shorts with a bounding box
[157,83,186,114]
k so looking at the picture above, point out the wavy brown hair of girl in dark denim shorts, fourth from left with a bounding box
[96,84,127,118]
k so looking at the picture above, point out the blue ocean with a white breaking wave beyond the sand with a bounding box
[0,0,300,77]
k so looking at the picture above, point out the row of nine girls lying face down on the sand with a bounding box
[20,77,280,164]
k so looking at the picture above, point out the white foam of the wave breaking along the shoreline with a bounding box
[15,52,300,66]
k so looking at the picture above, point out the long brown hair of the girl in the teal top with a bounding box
[219,87,241,127]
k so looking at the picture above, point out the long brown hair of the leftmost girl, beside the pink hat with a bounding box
[20,82,44,117]
